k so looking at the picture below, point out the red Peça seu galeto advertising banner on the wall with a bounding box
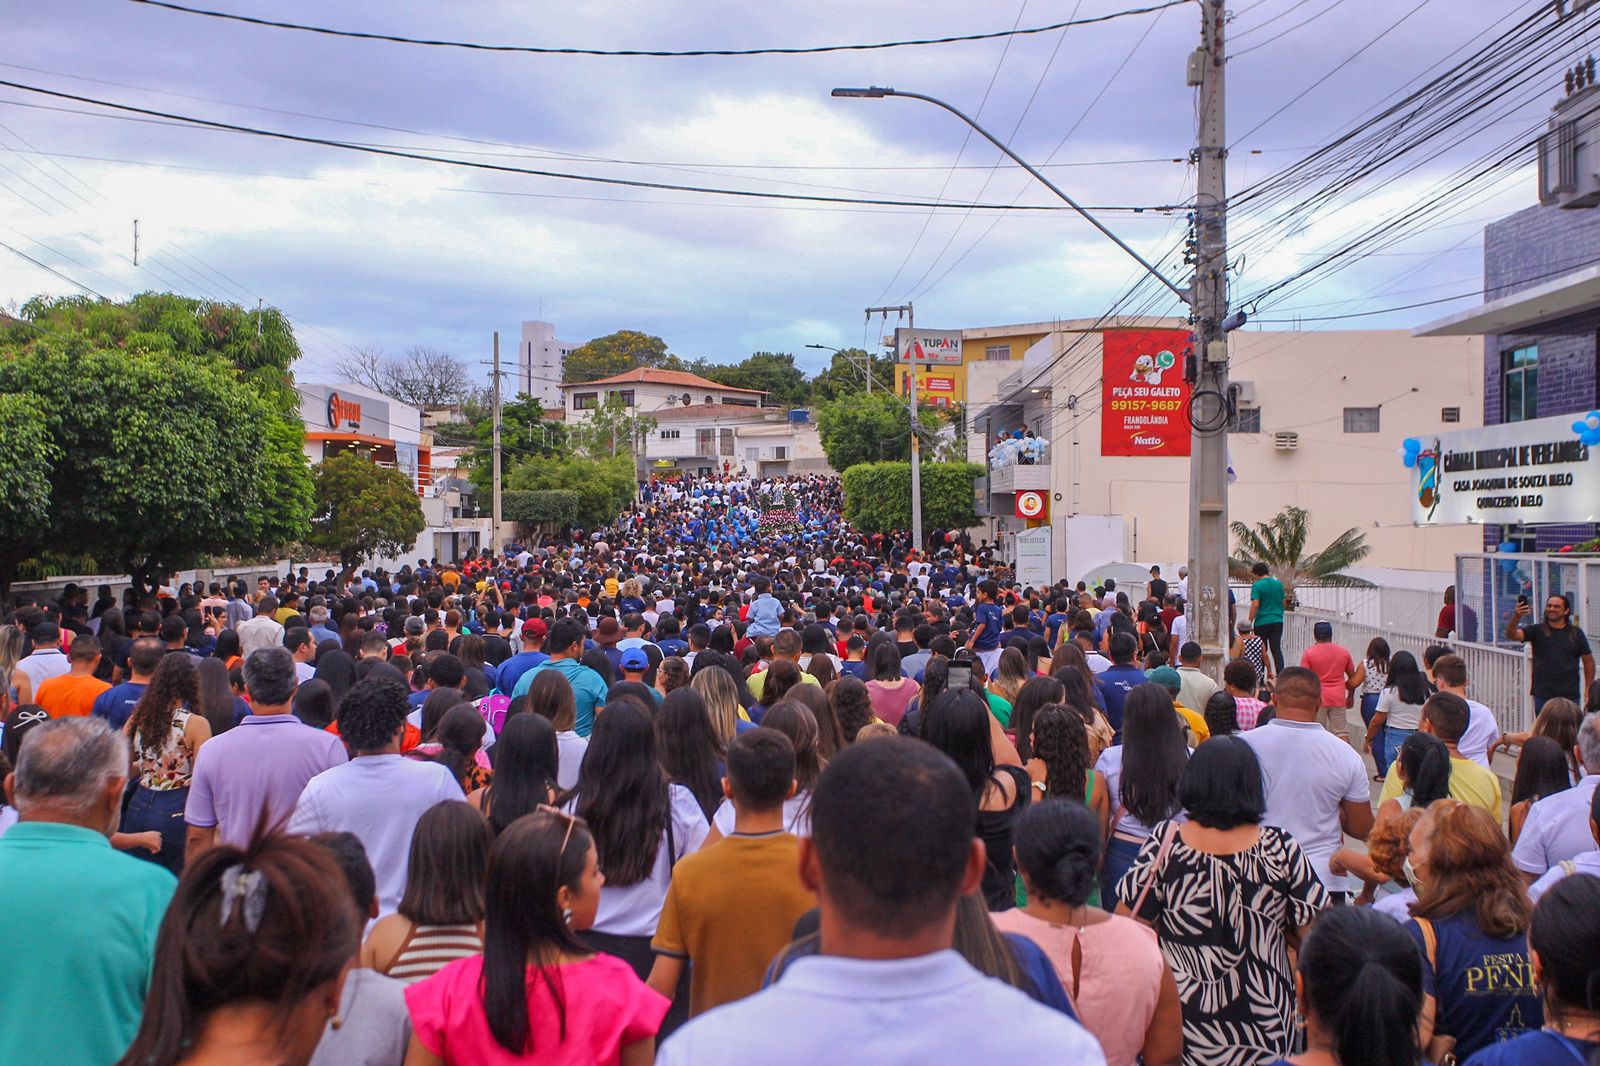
[1101,330,1190,456]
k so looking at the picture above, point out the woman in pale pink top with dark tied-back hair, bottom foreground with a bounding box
[990,799,1184,1066]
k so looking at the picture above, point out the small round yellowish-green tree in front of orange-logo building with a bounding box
[307,451,427,579]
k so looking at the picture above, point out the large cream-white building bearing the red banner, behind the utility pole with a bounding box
[968,319,1483,579]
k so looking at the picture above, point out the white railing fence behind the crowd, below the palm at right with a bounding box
[1283,607,1533,733]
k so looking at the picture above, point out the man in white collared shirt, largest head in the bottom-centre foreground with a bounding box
[656,741,1106,1066]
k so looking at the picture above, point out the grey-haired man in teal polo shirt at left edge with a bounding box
[0,717,178,1063]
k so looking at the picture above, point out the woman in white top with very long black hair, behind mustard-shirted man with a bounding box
[566,699,710,1031]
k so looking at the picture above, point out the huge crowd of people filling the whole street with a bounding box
[0,475,1600,1066]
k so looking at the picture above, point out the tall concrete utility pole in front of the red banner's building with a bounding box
[1189,0,1230,679]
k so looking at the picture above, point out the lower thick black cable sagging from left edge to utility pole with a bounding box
[0,78,1189,211]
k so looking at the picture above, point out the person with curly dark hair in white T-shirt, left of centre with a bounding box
[290,675,466,917]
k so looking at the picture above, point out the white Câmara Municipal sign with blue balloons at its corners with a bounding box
[1400,415,1600,525]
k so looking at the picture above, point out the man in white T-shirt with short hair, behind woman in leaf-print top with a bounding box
[1240,666,1373,892]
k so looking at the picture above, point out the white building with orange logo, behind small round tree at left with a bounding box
[298,383,490,568]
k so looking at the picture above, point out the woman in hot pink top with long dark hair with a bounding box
[405,807,670,1066]
